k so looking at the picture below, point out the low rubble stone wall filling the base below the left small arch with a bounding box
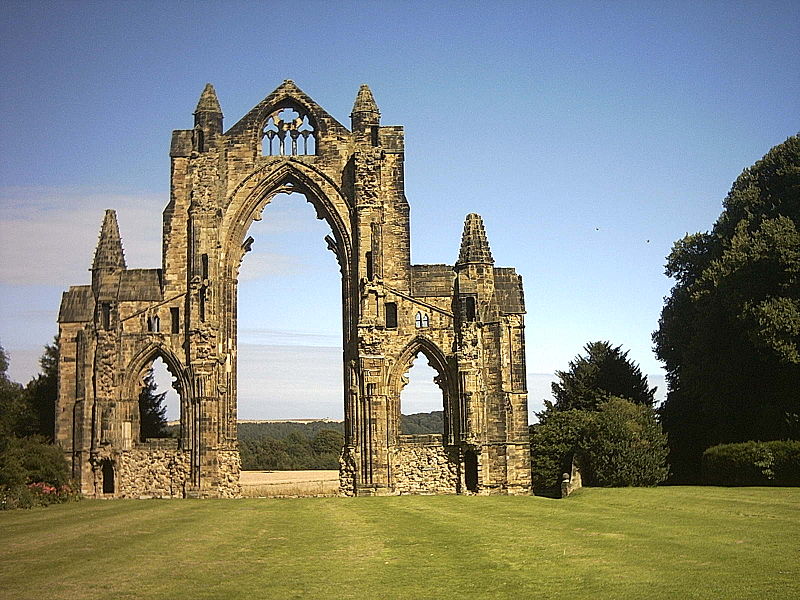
[115,444,190,498]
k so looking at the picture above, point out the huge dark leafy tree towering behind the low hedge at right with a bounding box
[653,136,800,481]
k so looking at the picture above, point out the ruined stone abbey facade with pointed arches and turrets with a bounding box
[56,80,530,497]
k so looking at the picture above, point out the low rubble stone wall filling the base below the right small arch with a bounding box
[390,435,459,494]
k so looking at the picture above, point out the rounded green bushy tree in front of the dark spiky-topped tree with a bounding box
[580,398,669,487]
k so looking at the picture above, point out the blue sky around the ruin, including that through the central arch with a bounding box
[0,1,800,417]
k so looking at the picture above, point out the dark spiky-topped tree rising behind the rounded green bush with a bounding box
[552,342,656,410]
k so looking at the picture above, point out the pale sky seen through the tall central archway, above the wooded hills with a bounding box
[236,193,343,419]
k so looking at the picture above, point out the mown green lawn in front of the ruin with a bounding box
[0,487,800,600]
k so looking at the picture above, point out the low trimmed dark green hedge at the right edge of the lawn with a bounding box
[702,440,800,486]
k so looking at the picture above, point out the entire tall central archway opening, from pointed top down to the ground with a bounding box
[236,192,344,496]
